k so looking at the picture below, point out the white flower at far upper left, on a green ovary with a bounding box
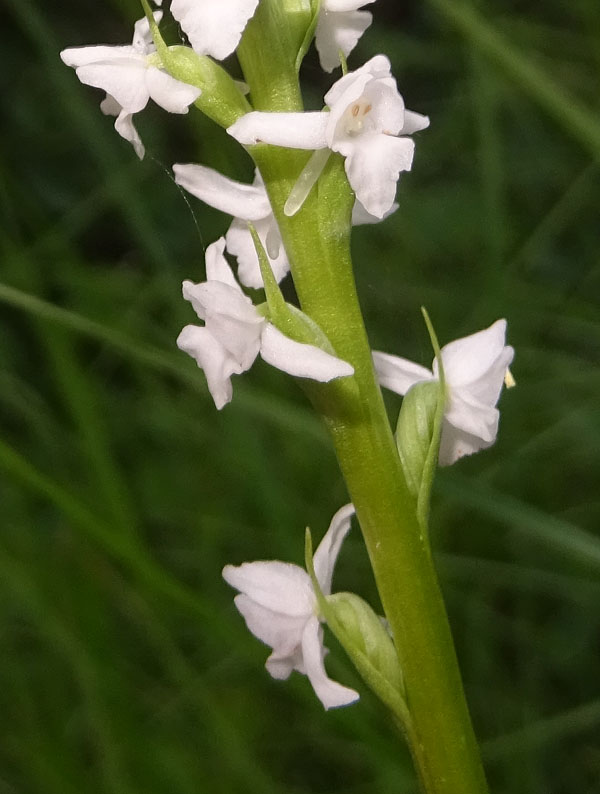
[60,11,201,159]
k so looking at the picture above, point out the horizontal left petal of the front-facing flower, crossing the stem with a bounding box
[227,110,329,149]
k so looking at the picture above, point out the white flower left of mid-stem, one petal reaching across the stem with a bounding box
[177,237,354,410]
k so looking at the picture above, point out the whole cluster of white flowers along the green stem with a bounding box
[61,0,514,708]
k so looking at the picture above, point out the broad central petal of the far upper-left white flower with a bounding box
[77,56,150,113]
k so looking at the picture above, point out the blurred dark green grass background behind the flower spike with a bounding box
[0,0,600,794]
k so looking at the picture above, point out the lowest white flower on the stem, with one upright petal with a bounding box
[223,504,359,709]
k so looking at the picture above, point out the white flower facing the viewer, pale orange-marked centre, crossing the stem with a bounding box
[227,55,429,218]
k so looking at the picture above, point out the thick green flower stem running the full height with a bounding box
[238,0,487,794]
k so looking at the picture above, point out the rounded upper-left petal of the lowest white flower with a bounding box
[223,560,316,619]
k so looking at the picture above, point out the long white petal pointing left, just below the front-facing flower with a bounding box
[173,163,271,221]
